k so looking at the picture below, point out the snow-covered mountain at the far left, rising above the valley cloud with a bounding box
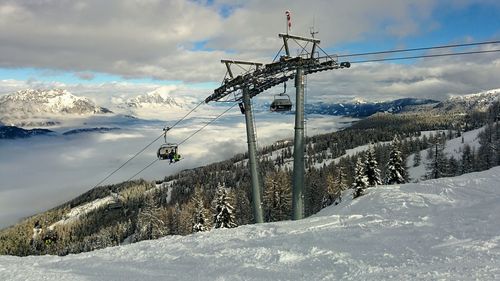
[0,89,110,126]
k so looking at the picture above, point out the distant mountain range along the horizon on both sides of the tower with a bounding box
[0,88,500,129]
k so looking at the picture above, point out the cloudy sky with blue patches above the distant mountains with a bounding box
[0,0,500,100]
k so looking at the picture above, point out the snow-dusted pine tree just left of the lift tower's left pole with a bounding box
[212,186,237,228]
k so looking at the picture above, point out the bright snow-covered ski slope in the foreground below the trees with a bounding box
[0,167,500,280]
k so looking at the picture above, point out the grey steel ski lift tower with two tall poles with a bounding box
[205,34,350,220]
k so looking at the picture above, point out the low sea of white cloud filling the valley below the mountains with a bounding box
[0,111,352,228]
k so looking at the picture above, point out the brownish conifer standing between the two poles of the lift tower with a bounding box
[263,171,292,221]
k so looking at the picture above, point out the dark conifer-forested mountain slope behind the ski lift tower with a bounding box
[0,96,500,255]
